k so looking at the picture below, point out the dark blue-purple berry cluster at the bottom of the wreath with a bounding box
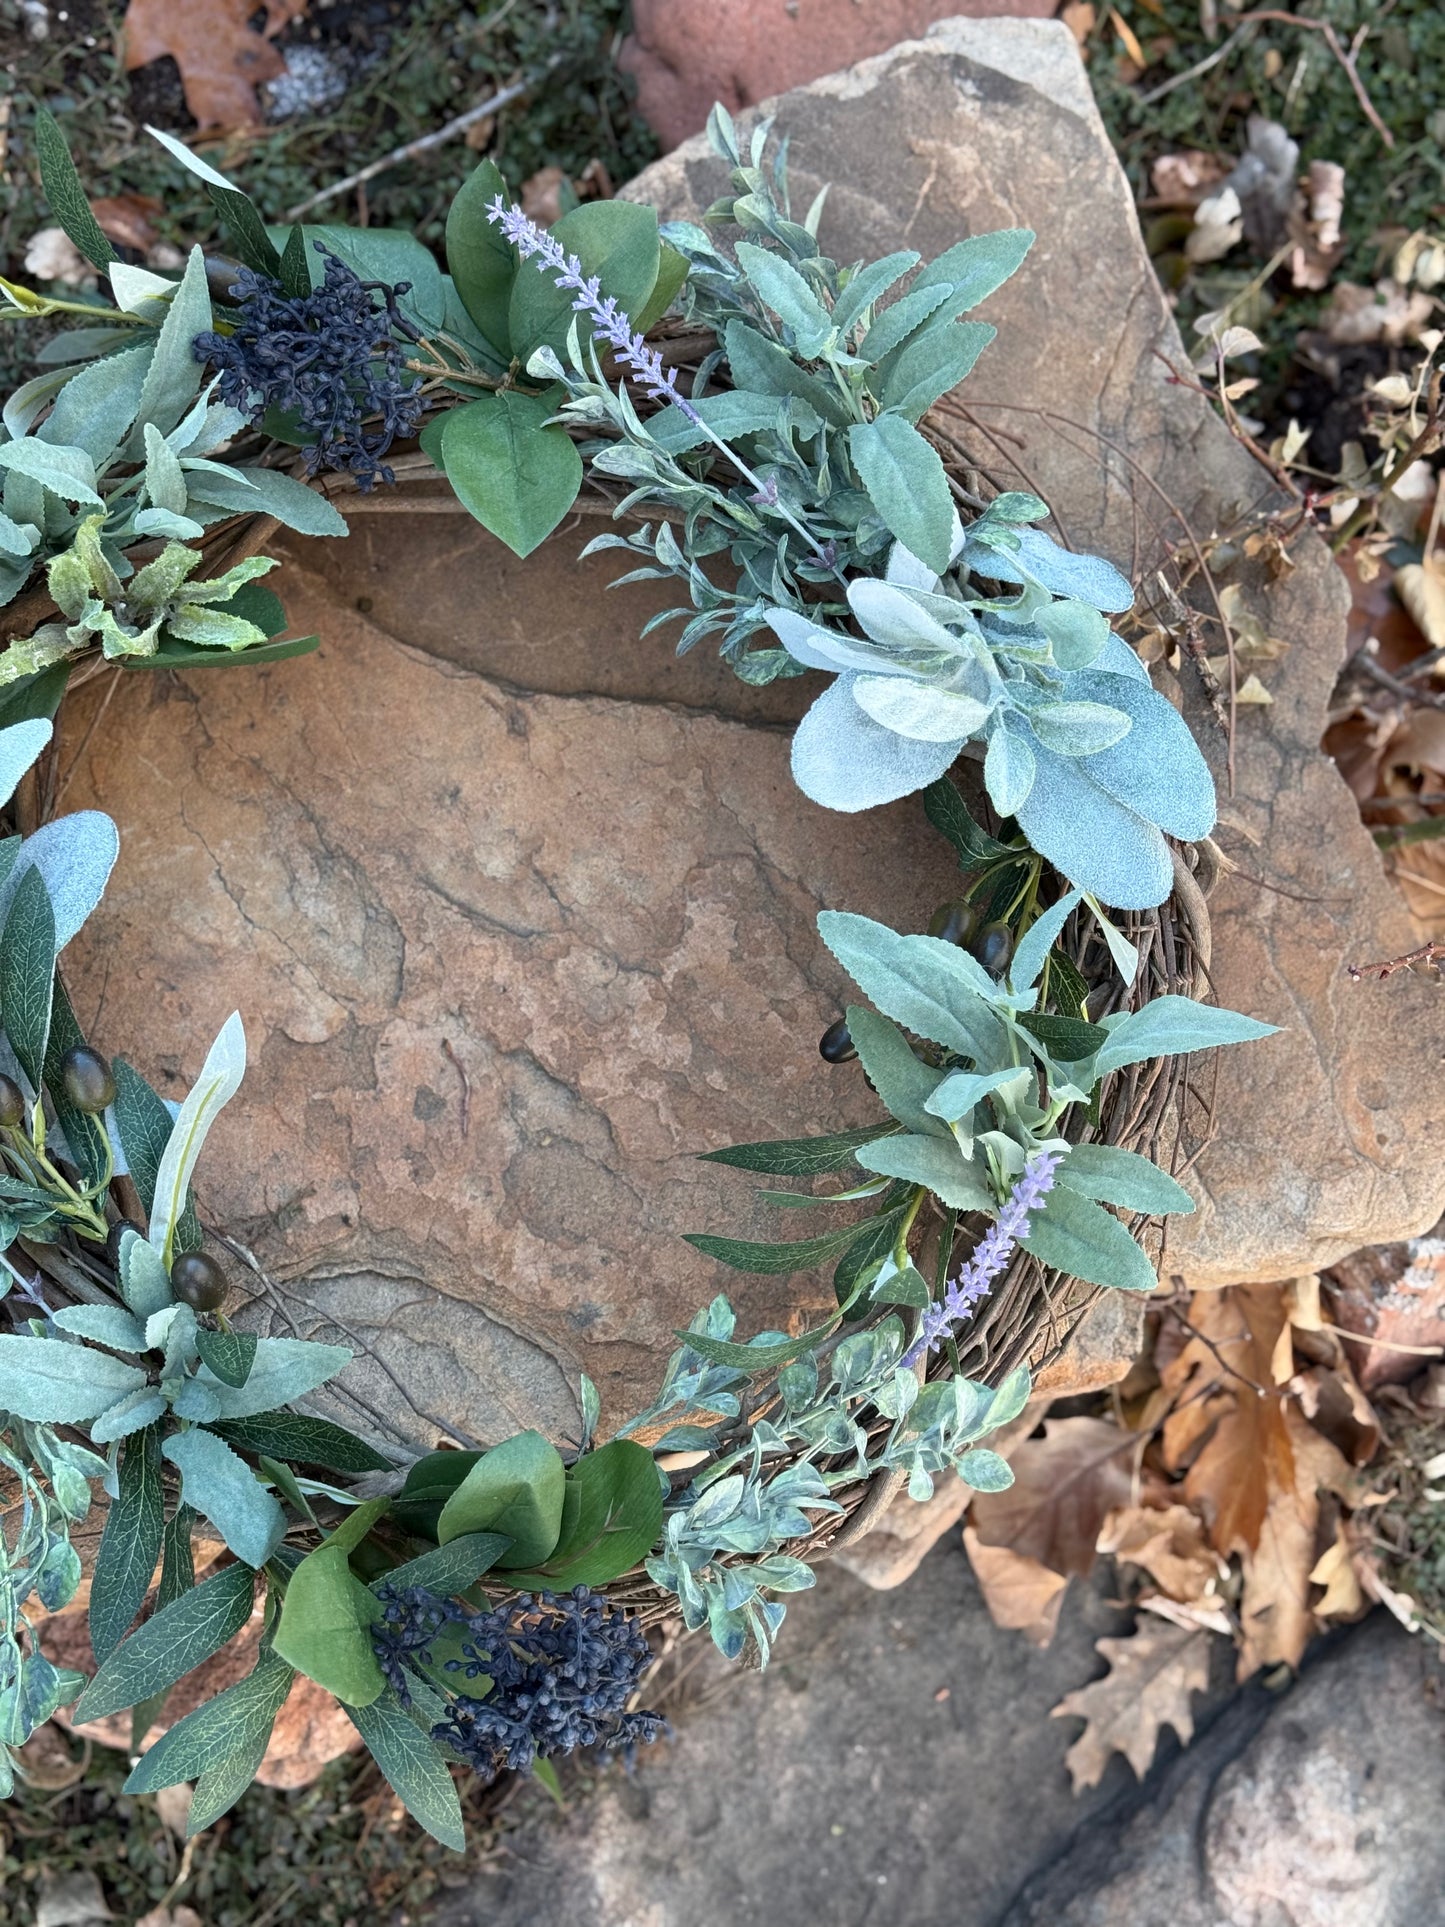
[372,1586,665,1779]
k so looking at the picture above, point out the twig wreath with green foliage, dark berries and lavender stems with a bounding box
[0,97,1268,1846]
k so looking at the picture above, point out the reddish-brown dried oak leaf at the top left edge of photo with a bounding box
[121,0,306,133]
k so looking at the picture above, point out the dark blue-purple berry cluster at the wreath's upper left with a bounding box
[193,241,426,489]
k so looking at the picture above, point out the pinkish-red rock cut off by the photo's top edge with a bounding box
[618,0,1056,146]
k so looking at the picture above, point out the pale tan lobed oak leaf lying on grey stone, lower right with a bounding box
[1052,1621,1210,1794]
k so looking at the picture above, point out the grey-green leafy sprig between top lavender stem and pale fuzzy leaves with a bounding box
[559,108,1033,682]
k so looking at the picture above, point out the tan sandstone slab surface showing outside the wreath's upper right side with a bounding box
[626,19,1445,1285]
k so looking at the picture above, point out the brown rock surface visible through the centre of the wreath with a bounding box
[62,515,956,1443]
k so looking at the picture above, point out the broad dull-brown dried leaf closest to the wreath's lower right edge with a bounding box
[973,1418,1137,1578]
